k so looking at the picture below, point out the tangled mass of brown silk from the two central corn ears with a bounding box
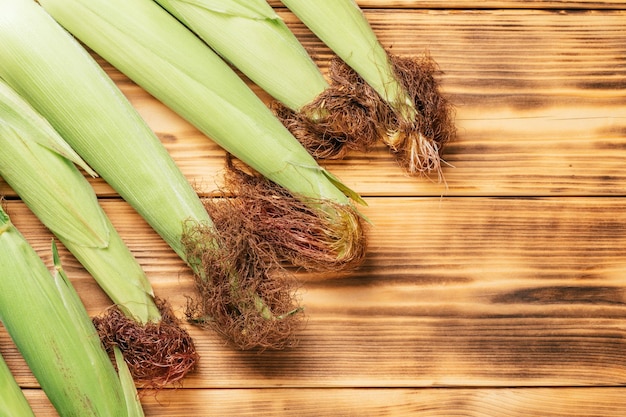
[183,155,367,350]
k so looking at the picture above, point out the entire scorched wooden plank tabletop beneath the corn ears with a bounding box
[0,0,626,417]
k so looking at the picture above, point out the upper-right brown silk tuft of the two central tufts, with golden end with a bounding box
[217,161,367,273]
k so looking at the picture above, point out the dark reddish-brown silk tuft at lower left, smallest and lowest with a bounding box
[92,299,198,389]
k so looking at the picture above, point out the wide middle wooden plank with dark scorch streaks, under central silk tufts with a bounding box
[0,198,626,388]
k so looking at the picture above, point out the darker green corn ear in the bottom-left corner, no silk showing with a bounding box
[0,207,138,417]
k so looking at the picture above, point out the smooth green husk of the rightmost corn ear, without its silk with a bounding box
[276,0,417,121]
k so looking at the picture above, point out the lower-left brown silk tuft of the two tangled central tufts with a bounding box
[182,199,304,351]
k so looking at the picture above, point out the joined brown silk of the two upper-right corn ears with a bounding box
[272,55,456,180]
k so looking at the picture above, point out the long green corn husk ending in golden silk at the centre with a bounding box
[40,0,364,270]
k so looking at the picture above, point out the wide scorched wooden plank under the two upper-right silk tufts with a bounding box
[0,10,626,196]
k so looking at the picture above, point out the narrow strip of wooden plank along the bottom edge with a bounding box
[25,388,626,417]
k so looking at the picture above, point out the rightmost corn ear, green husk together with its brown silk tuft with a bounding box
[281,0,456,179]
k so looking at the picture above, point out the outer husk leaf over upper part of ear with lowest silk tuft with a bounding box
[0,79,109,248]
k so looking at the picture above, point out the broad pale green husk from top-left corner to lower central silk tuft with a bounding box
[0,0,211,259]
